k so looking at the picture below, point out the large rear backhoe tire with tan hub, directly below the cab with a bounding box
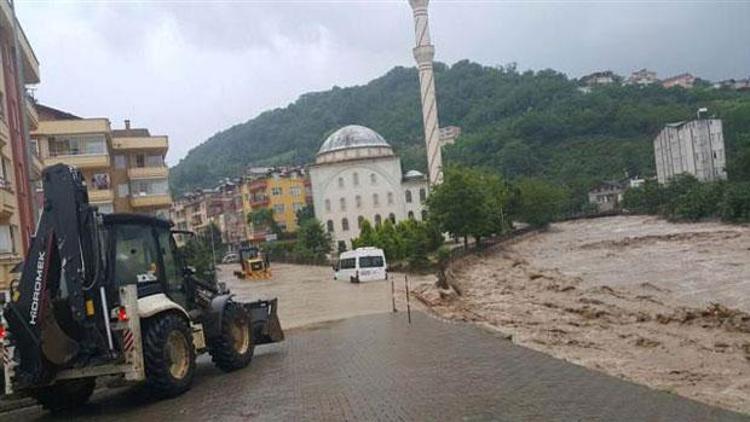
[143,313,195,398]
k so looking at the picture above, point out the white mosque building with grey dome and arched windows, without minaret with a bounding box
[310,125,429,248]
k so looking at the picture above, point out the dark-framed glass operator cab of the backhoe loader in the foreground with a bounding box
[103,214,188,307]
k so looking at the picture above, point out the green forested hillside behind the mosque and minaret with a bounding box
[170,60,750,209]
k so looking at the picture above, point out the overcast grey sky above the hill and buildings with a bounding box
[16,0,750,164]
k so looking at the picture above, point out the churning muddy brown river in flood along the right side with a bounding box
[416,217,750,413]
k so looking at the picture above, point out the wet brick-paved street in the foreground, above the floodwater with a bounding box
[5,313,747,421]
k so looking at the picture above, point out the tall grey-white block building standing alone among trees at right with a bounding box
[654,119,727,184]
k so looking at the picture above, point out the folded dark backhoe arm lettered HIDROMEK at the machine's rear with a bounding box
[4,164,104,385]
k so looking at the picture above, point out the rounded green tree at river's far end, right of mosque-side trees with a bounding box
[517,178,567,227]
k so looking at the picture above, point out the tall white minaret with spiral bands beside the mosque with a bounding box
[409,0,443,185]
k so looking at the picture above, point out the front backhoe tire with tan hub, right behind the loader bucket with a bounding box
[208,301,255,372]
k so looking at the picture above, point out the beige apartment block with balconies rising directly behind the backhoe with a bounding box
[31,112,172,218]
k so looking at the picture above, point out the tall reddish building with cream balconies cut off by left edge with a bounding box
[0,1,41,289]
